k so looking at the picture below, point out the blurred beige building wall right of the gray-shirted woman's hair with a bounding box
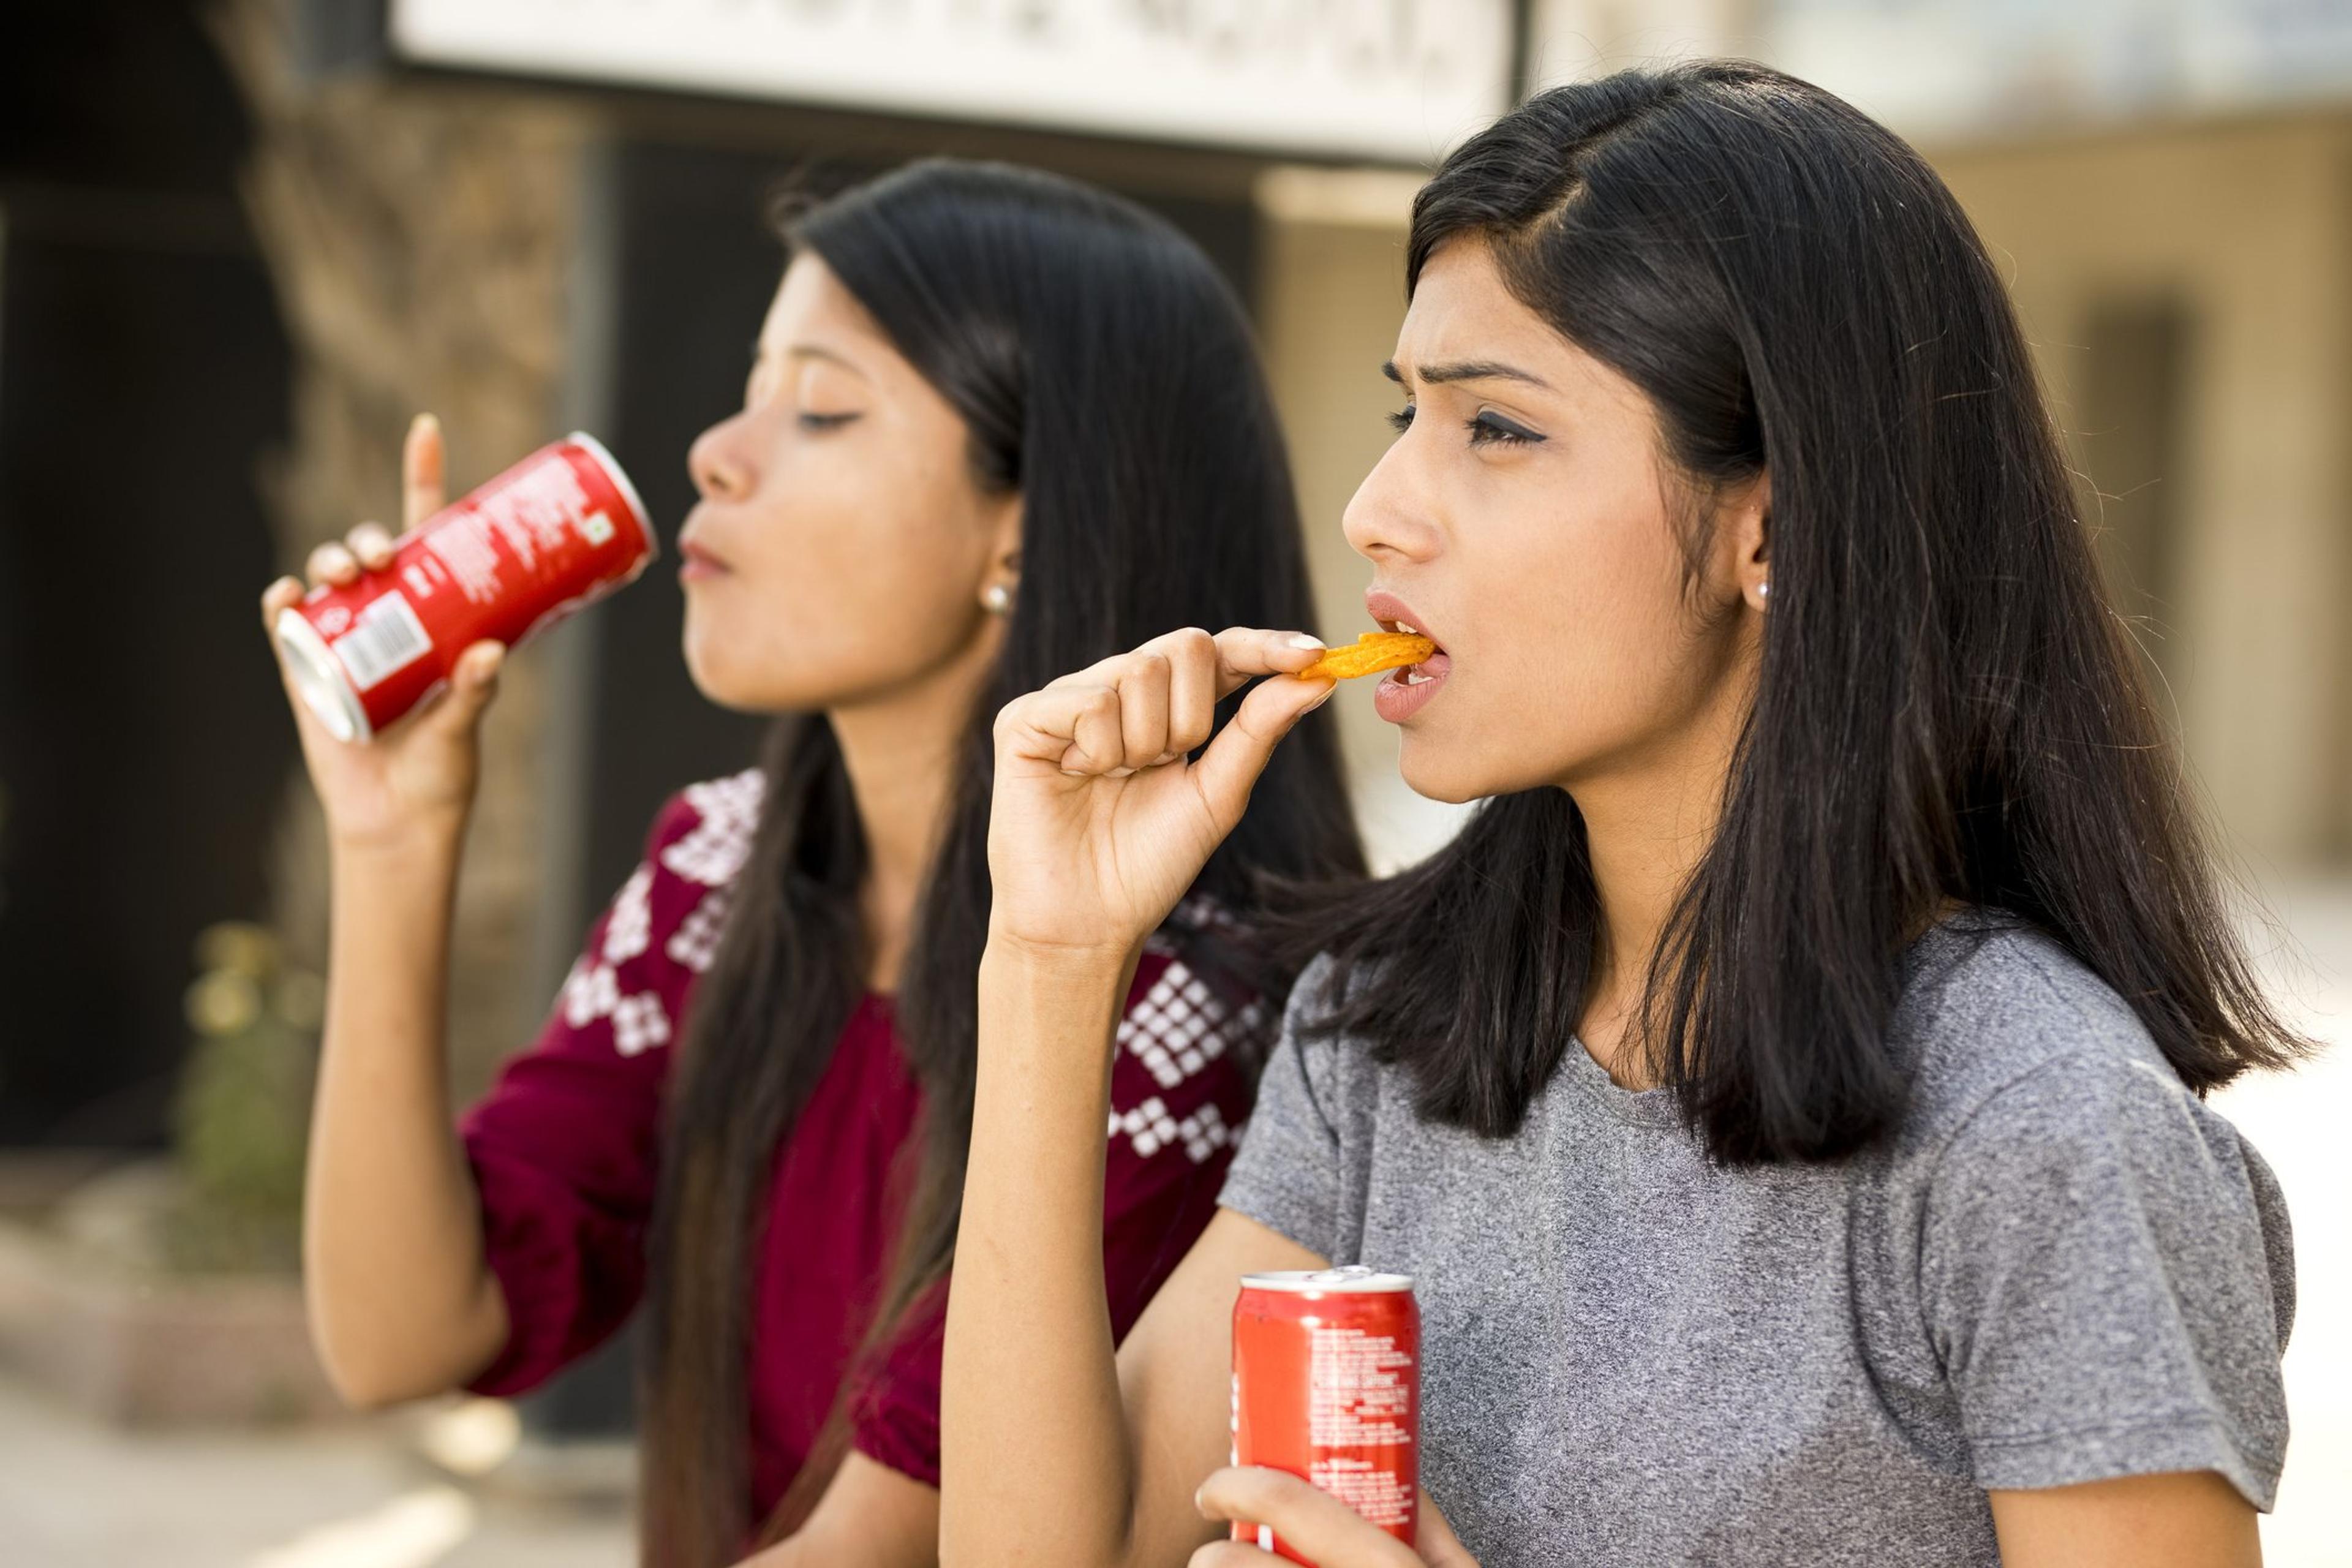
[1936,118,2352,872]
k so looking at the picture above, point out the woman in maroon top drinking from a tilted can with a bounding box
[263,162,1362,1568]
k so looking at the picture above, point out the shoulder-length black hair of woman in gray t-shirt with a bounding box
[1301,61,2307,1164]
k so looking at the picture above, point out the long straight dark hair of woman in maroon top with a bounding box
[642,160,1364,1568]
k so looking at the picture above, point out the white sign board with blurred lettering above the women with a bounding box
[386,0,1517,165]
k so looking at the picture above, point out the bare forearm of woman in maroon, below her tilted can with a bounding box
[303,832,506,1403]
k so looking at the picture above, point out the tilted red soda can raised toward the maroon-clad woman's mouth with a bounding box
[275,430,658,741]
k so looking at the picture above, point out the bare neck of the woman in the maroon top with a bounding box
[826,637,1000,992]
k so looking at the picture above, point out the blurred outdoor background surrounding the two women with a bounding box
[0,0,2352,1568]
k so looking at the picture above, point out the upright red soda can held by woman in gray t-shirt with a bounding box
[1232,1267,1420,1563]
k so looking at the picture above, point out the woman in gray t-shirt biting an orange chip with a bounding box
[941,64,2302,1568]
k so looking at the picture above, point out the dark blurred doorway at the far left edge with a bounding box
[0,0,294,1147]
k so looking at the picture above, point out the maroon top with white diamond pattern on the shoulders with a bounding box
[461,771,1261,1517]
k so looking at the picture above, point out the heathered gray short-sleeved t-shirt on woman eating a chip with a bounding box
[1223,914,2293,1568]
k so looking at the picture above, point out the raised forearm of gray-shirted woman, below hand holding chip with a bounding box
[941,945,1134,1568]
